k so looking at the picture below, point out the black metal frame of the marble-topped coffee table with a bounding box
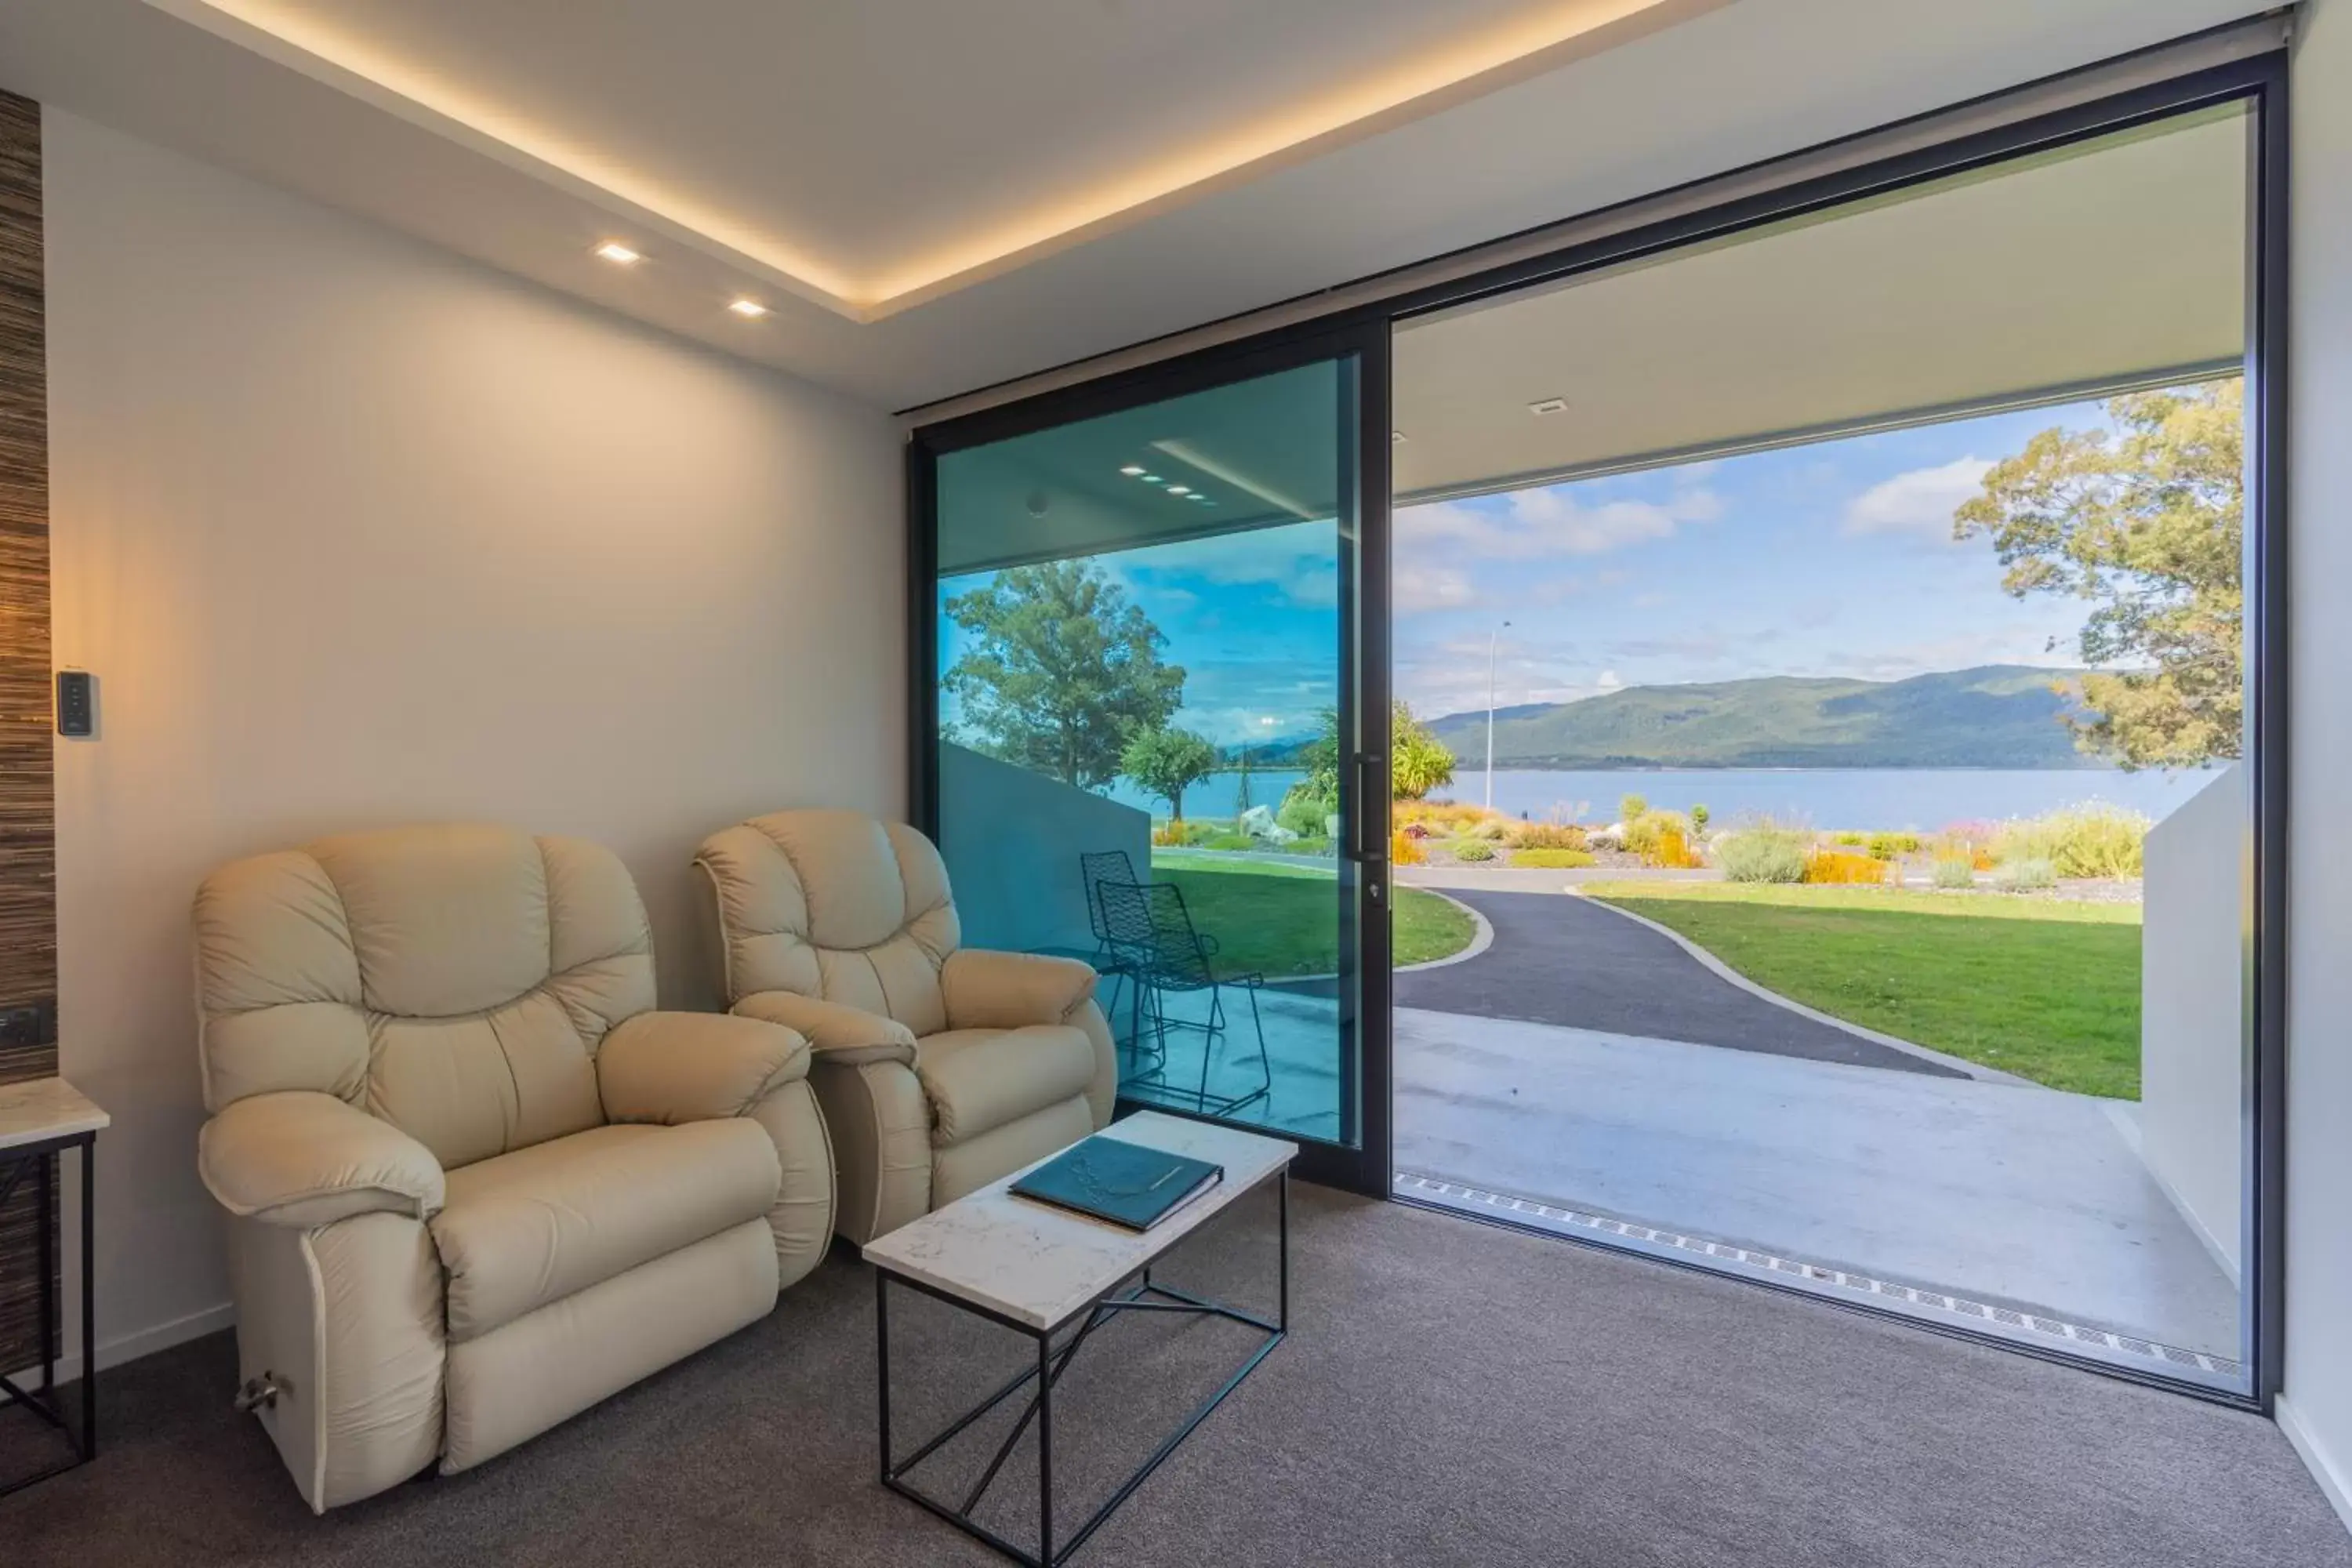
[875,1166,1291,1568]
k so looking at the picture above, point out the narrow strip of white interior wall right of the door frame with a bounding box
[2279,0,2352,1526]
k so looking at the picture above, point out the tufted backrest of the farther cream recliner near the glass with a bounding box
[694,811,962,1034]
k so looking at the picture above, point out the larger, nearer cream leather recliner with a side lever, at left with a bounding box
[195,825,833,1512]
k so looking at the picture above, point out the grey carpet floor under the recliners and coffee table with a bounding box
[0,1187,2352,1568]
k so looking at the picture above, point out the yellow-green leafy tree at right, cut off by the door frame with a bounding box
[1952,379,2246,769]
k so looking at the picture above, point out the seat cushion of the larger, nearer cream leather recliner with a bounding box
[433,1119,783,1342]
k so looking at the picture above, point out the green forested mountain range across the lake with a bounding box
[1430,666,2100,769]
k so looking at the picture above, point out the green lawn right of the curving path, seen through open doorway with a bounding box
[1585,881,2140,1100]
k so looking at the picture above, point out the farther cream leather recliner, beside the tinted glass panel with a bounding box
[694,811,1120,1241]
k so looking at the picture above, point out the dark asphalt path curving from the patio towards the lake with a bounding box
[1397,884,1969,1079]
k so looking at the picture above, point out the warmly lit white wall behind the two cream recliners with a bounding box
[45,111,903,1359]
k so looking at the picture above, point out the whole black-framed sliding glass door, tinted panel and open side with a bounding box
[910,34,2286,1408]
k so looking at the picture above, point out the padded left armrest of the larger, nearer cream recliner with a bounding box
[195,1088,447,1229]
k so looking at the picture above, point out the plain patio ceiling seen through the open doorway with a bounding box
[1392,108,2249,501]
